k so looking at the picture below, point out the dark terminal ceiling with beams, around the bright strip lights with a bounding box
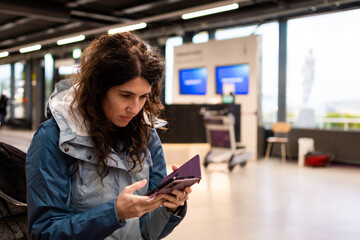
[0,0,360,63]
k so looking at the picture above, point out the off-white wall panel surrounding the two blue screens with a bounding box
[173,35,261,156]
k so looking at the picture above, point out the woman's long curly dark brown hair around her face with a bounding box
[71,32,164,178]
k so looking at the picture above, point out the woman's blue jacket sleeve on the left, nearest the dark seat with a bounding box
[26,119,124,239]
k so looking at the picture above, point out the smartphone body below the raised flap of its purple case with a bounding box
[146,176,200,197]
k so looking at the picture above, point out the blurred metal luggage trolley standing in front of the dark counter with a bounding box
[200,108,253,171]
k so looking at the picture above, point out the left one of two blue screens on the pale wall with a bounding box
[179,67,207,95]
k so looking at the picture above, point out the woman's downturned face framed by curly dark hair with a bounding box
[102,77,151,127]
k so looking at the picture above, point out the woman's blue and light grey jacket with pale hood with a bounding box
[26,81,186,240]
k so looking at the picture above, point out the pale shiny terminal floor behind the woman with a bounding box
[0,126,360,240]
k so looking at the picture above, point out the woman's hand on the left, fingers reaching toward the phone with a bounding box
[115,179,163,220]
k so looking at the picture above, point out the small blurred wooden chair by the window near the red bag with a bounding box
[265,122,291,163]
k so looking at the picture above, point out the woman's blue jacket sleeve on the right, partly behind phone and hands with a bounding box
[140,129,187,239]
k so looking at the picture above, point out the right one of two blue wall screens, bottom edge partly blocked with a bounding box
[216,64,250,95]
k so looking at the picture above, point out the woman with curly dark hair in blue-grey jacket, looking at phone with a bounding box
[26,33,191,239]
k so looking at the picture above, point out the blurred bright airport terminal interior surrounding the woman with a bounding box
[0,0,360,240]
